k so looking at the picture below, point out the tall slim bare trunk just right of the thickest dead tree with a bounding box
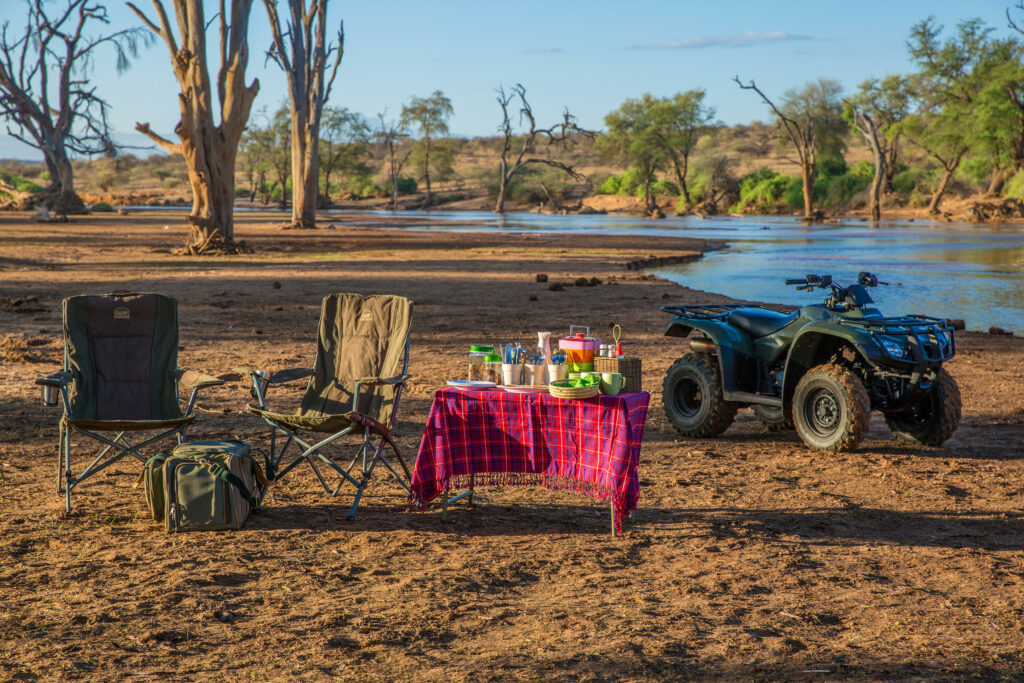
[263,0,345,228]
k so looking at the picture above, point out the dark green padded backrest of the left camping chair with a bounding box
[63,294,181,420]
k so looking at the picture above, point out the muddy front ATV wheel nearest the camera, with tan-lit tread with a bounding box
[793,362,871,452]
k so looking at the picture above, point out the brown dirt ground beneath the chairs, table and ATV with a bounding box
[0,211,1024,681]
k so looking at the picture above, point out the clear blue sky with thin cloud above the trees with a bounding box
[0,0,1024,159]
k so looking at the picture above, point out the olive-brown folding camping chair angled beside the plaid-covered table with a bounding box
[237,294,413,520]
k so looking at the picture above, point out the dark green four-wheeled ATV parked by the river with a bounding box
[662,272,961,451]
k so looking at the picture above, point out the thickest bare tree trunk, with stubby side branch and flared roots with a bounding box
[127,0,259,254]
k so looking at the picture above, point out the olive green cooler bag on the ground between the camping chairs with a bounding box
[143,441,268,531]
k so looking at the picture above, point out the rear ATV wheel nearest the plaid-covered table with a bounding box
[662,353,739,437]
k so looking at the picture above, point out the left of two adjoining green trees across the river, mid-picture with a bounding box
[597,93,669,213]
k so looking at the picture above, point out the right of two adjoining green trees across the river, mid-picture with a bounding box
[652,89,715,206]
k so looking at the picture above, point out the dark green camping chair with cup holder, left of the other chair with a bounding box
[36,294,224,513]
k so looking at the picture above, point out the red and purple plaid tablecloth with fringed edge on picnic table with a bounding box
[409,388,650,530]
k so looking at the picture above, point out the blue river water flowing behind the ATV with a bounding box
[321,211,1024,333]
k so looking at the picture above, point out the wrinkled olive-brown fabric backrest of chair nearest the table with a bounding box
[299,294,413,426]
